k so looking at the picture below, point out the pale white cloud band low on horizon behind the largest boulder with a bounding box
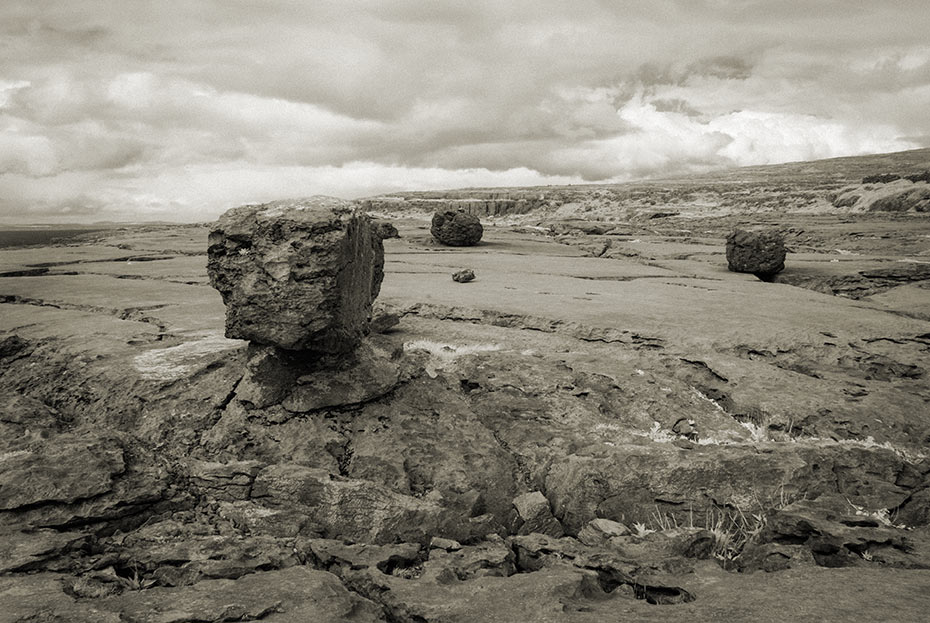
[0,162,581,221]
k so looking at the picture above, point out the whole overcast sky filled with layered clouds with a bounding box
[0,0,930,222]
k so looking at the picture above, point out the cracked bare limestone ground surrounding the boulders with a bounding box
[0,199,930,623]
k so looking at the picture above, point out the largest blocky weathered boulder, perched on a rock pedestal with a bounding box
[207,196,384,353]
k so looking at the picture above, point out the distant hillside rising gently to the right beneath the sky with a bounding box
[361,149,930,220]
